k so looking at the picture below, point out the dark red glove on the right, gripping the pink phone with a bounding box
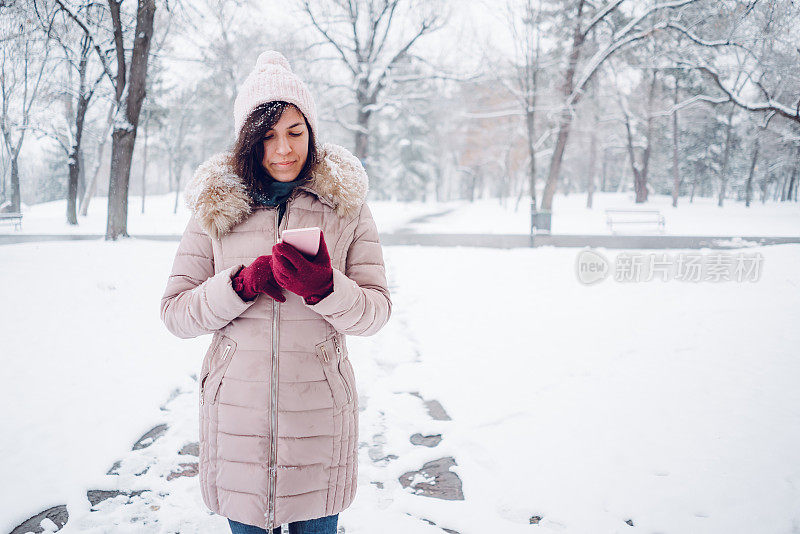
[272,230,333,304]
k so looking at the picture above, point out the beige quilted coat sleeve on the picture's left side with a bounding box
[161,216,255,339]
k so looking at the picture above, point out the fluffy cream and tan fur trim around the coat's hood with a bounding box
[184,143,369,239]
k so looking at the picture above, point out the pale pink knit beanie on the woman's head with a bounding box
[233,50,319,144]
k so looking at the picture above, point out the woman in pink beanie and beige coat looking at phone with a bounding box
[161,51,391,534]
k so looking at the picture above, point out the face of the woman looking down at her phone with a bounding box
[261,106,309,182]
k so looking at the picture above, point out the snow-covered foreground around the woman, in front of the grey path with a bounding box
[0,234,800,534]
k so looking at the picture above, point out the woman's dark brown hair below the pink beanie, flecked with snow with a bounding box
[232,100,318,201]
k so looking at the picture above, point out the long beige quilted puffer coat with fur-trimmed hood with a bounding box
[161,144,392,530]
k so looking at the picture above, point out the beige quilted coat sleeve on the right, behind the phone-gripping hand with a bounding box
[306,202,392,336]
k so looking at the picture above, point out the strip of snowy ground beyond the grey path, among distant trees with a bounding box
[6,193,800,236]
